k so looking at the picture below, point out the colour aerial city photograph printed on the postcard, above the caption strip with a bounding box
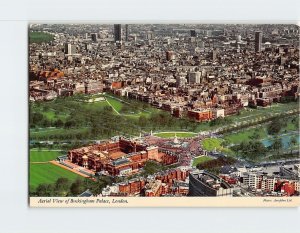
[28,23,300,201]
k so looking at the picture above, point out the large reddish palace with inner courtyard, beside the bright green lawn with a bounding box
[68,138,178,175]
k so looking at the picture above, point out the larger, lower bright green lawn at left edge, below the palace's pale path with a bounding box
[29,163,81,191]
